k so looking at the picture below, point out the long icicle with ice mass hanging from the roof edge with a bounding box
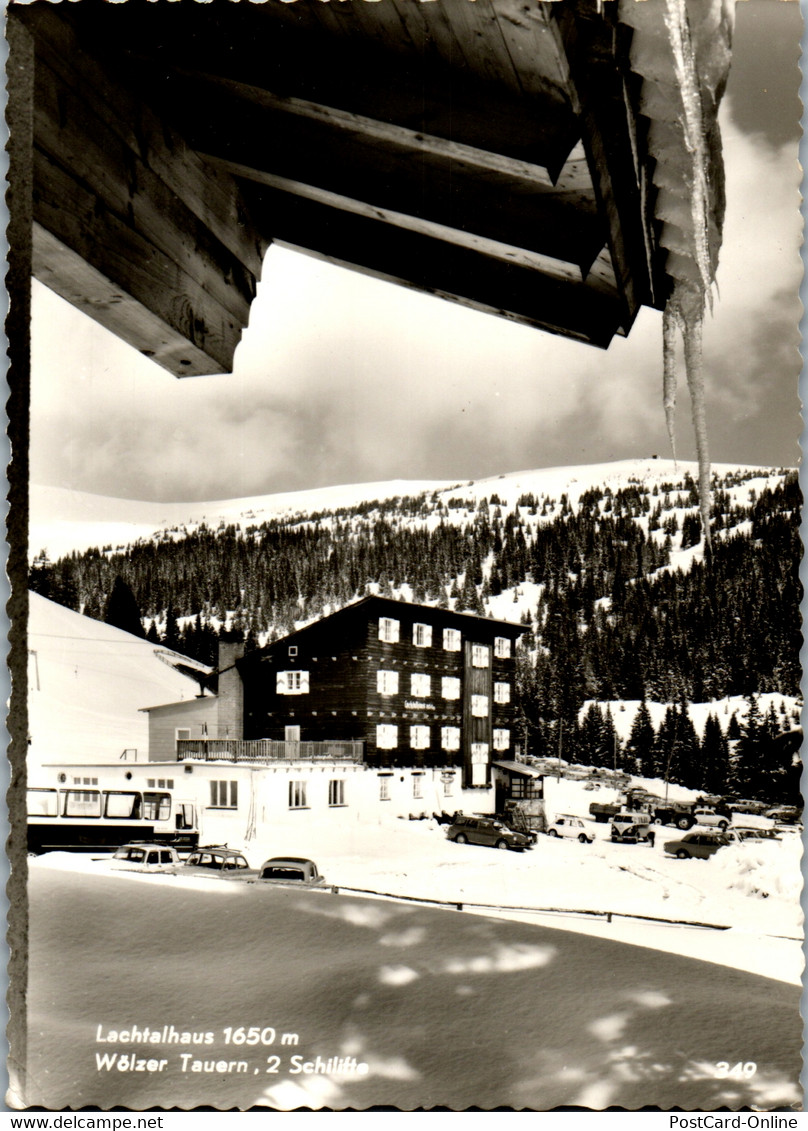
[620,0,734,545]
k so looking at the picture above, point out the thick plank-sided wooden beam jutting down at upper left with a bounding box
[22,6,266,377]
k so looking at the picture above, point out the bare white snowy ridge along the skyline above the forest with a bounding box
[29,458,774,561]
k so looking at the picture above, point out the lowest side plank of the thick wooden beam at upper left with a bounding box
[34,150,241,375]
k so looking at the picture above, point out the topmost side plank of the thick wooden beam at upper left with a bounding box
[22,0,266,277]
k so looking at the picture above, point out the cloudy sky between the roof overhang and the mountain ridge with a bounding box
[31,0,802,501]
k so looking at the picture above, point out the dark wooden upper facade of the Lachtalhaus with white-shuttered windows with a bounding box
[239,597,524,785]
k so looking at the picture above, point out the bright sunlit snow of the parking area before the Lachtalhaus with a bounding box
[32,779,802,985]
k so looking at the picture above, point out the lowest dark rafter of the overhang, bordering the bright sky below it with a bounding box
[245,185,622,347]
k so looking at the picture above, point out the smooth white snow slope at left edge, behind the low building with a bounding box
[28,593,209,770]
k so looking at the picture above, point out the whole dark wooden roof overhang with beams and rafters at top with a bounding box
[9,0,665,375]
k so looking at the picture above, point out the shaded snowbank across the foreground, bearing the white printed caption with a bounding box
[26,850,801,1111]
